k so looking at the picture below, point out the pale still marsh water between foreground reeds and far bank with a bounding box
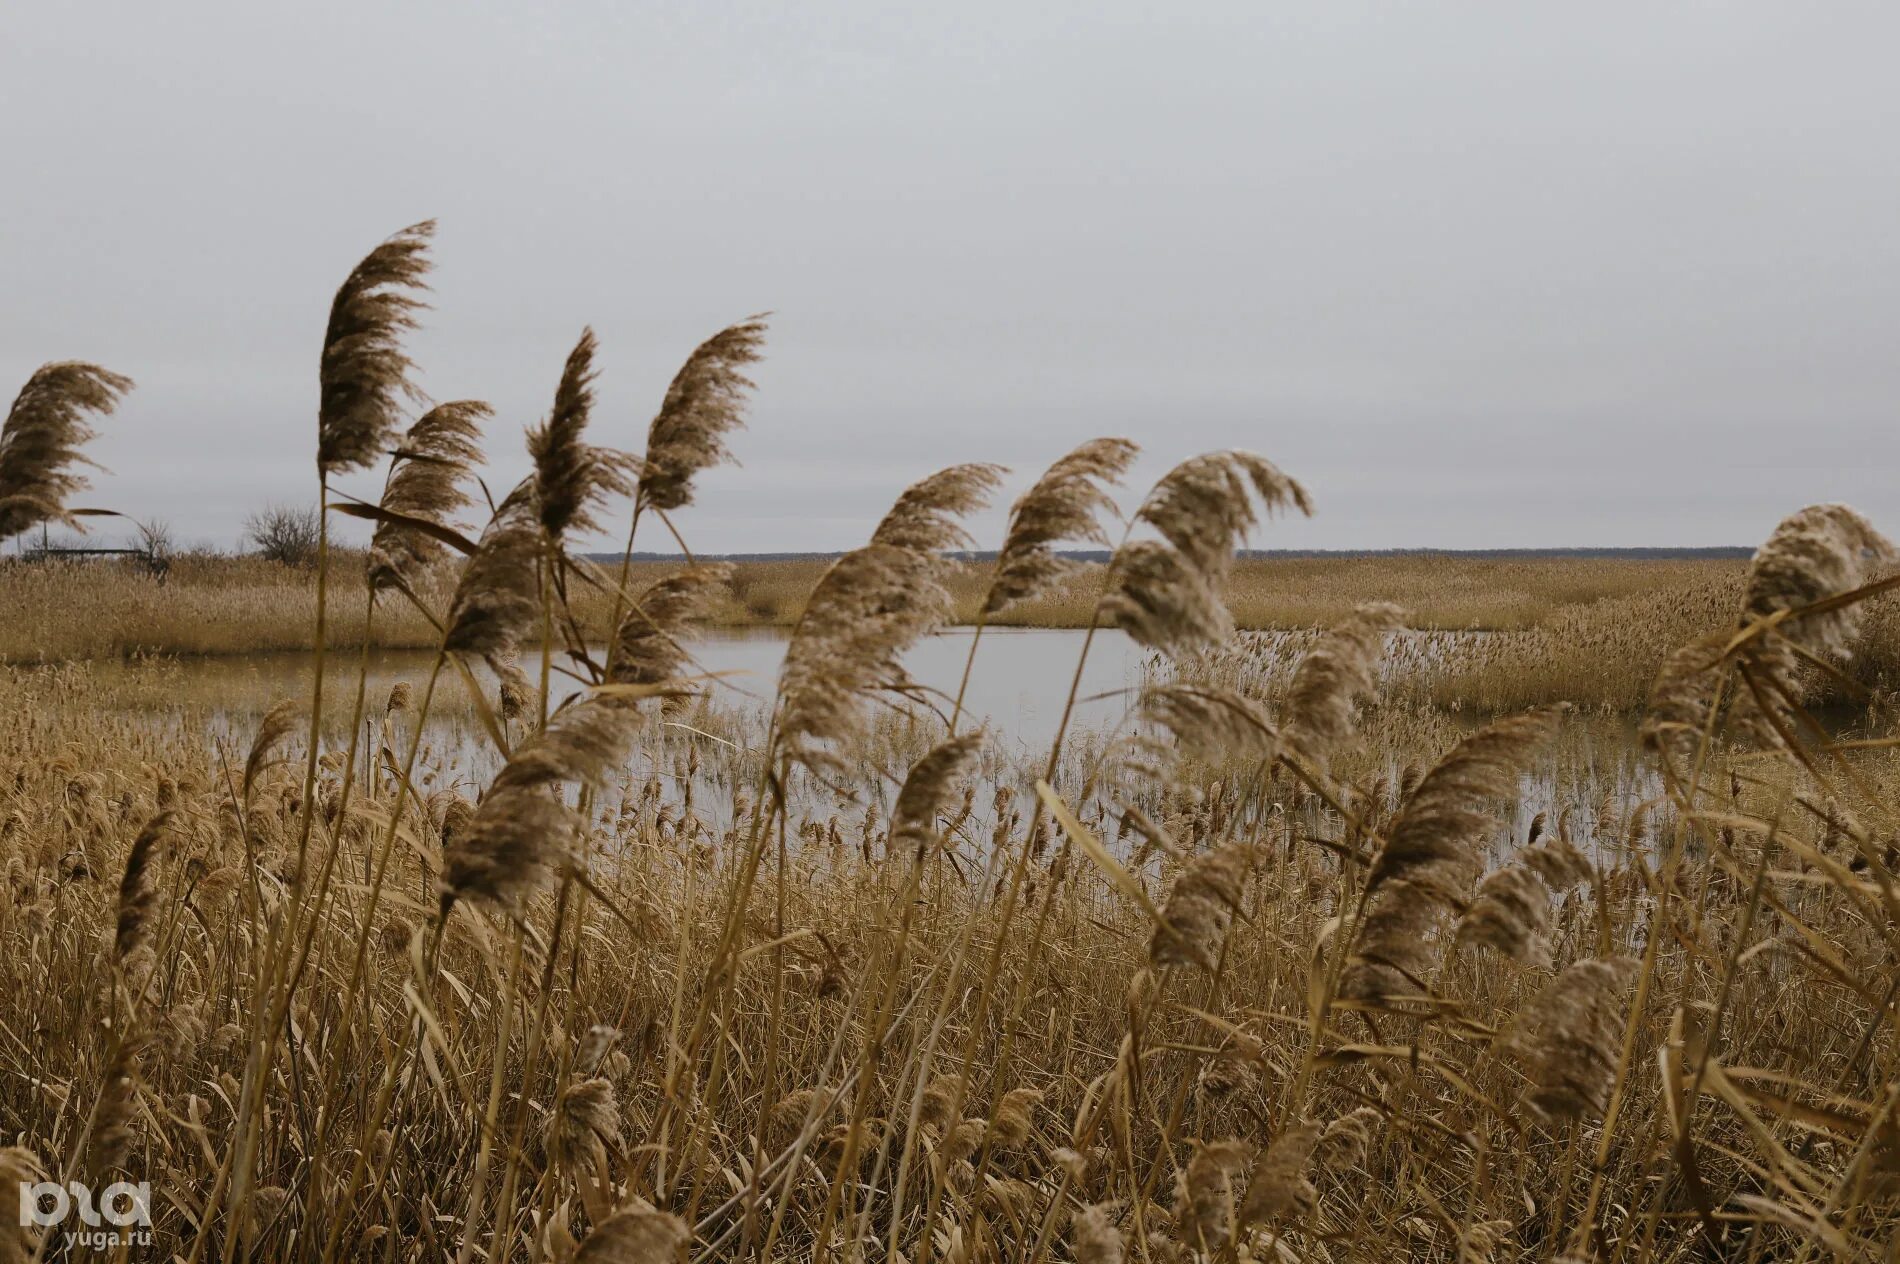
[55,627,1659,866]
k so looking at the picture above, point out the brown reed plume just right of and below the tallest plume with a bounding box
[369,399,494,593]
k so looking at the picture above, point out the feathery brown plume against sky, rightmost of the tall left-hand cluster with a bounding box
[637,314,766,511]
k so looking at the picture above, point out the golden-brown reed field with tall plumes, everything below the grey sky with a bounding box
[0,224,1900,1264]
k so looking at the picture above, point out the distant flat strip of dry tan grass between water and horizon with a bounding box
[0,553,1746,663]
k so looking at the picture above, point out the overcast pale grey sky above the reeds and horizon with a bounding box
[0,0,1900,551]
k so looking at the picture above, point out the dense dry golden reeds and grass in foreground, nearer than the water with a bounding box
[0,619,1900,1258]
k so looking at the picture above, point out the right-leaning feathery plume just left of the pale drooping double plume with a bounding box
[982,439,1140,616]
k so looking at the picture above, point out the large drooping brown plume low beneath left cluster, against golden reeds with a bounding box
[441,696,640,920]
